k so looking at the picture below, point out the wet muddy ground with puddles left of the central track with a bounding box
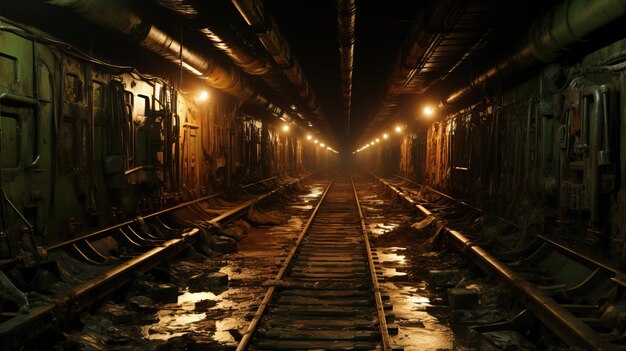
[58,179,328,351]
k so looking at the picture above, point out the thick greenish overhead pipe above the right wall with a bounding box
[445,0,626,104]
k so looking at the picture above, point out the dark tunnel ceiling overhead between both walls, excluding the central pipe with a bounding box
[6,0,624,151]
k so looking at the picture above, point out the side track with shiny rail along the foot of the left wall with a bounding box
[0,175,309,349]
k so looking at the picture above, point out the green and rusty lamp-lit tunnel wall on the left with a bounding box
[0,19,334,256]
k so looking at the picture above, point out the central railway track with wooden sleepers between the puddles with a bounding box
[237,174,391,350]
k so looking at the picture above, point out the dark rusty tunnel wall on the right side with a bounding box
[390,39,626,260]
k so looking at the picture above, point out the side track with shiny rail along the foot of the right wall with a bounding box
[376,176,626,350]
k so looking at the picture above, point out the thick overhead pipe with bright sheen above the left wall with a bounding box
[48,0,268,106]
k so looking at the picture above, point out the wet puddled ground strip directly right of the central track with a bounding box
[357,182,454,351]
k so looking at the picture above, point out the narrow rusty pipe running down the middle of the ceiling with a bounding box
[337,0,356,142]
